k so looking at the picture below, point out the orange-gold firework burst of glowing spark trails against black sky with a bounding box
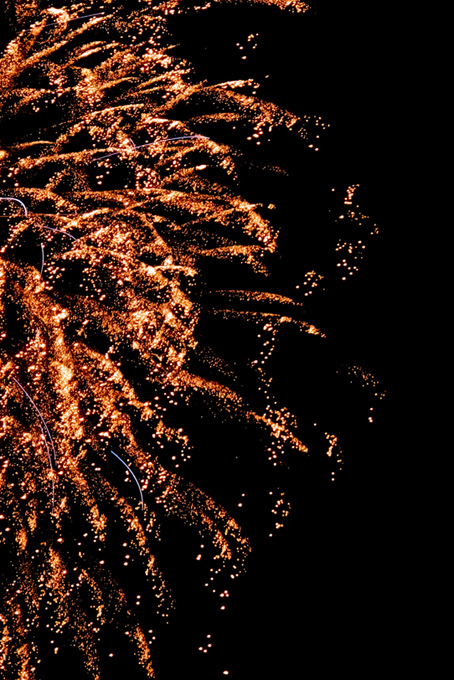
[0,0,384,680]
